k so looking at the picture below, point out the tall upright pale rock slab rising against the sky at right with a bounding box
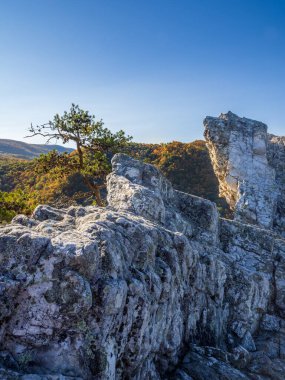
[204,112,285,234]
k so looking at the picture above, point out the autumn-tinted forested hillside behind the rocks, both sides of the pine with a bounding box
[0,137,232,223]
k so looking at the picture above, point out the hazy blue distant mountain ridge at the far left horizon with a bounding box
[0,139,74,160]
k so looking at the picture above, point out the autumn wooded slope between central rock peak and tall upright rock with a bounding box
[126,140,231,218]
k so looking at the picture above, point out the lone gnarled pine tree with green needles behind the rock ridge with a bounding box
[27,104,131,206]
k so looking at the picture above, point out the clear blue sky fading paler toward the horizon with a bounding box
[0,0,285,143]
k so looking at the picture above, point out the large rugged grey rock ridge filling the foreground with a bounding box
[0,155,285,380]
